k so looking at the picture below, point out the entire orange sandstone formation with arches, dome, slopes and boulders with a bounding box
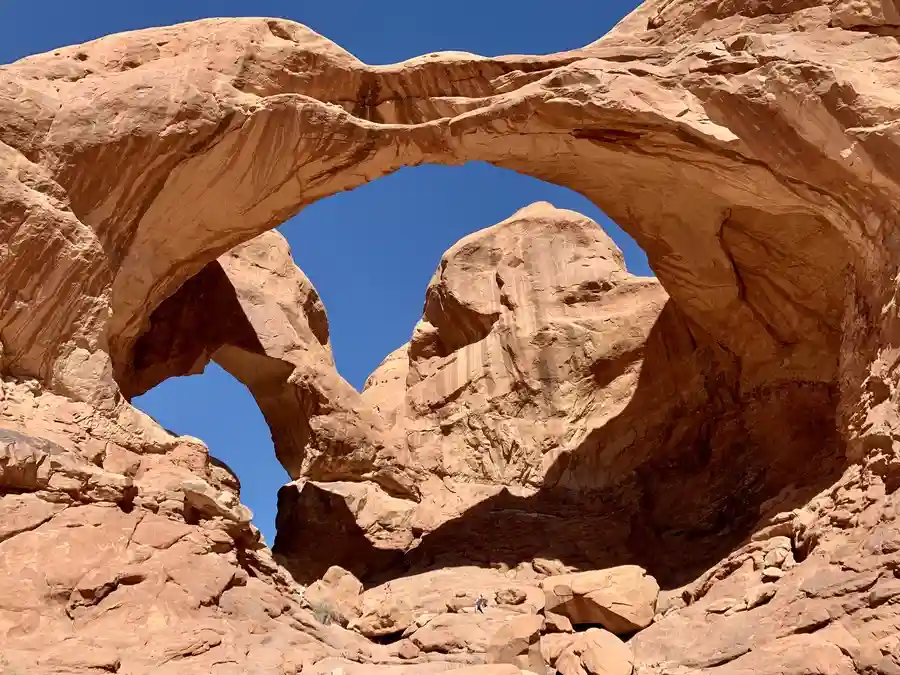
[0,0,900,675]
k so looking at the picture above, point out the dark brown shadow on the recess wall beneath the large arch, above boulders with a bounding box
[273,301,845,588]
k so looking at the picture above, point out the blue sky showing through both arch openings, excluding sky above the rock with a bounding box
[134,162,652,544]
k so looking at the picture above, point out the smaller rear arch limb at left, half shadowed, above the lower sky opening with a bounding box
[119,232,416,496]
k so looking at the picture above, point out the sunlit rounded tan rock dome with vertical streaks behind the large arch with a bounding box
[386,198,666,486]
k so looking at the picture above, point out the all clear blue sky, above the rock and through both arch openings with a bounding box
[0,0,650,543]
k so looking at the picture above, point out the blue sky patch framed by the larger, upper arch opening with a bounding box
[278,162,653,391]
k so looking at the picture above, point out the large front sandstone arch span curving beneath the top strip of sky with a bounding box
[0,6,892,422]
